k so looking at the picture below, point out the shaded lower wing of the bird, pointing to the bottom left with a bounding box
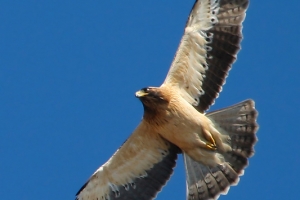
[76,122,179,200]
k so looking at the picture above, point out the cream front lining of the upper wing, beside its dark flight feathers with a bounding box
[164,0,219,106]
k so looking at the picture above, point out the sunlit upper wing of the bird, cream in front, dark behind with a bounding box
[163,0,249,112]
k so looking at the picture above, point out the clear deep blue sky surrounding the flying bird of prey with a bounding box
[0,0,300,200]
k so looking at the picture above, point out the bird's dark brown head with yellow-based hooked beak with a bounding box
[135,87,168,115]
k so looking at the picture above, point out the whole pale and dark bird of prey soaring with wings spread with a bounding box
[76,0,258,200]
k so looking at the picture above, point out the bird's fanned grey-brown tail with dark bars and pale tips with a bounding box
[184,100,258,200]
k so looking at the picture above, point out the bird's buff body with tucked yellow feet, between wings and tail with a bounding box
[141,85,230,166]
